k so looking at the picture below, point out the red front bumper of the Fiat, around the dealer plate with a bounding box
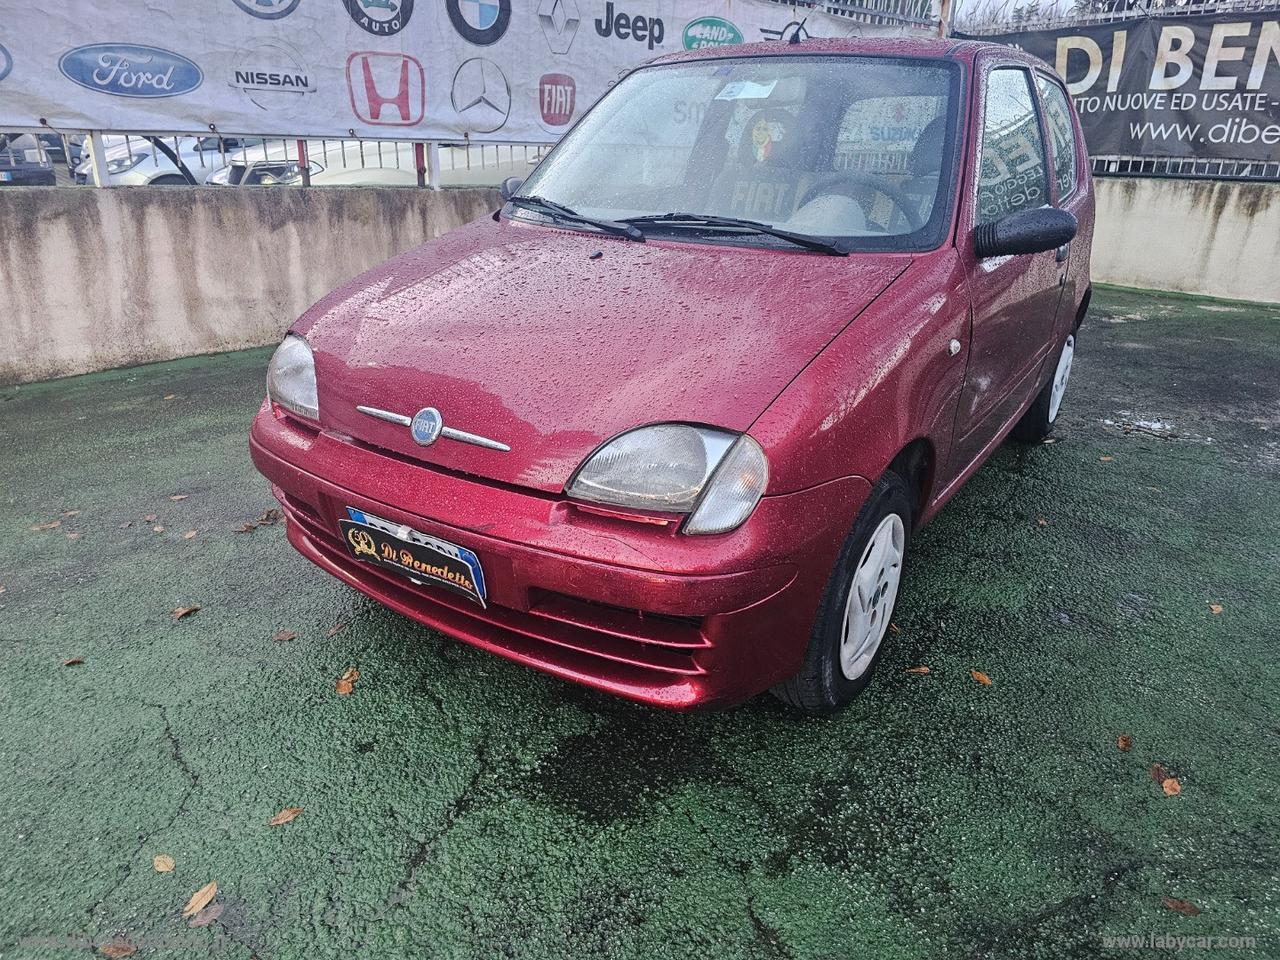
[250,403,869,709]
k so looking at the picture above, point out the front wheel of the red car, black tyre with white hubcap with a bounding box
[773,472,915,714]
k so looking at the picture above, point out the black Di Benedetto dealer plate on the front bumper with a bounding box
[338,507,485,607]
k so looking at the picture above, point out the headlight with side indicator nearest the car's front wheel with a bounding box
[567,424,769,534]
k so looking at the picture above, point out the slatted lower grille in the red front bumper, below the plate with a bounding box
[284,497,710,684]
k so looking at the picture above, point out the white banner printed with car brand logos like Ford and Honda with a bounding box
[0,0,911,142]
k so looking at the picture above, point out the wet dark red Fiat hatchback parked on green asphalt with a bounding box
[251,40,1093,712]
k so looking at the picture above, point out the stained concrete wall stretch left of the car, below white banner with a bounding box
[0,187,499,383]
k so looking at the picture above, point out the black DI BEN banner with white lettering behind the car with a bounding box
[957,10,1280,161]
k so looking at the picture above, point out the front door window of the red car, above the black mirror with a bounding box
[978,68,1048,223]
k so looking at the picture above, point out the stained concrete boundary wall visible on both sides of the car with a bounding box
[0,178,1280,383]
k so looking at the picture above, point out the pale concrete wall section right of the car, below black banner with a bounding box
[1093,177,1280,302]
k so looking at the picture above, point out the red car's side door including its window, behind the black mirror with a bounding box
[952,63,1065,472]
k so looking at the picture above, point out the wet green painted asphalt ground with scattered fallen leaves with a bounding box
[0,289,1280,960]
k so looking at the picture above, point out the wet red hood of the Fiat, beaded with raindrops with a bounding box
[294,218,910,493]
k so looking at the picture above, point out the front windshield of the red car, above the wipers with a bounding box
[508,55,959,251]
